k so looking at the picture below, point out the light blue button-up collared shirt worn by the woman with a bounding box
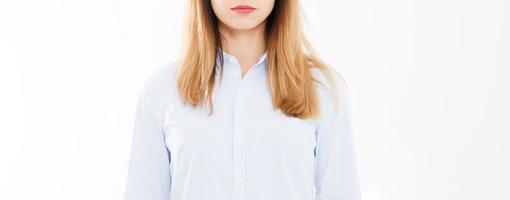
[124,48,361,200]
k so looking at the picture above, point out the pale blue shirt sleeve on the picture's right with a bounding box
[315,71,361,200]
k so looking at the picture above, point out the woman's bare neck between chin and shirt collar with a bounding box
[218,21,266,72]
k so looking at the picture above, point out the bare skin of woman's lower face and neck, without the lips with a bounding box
[211,0,275,77]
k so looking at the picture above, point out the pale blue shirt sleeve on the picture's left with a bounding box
[124,83,171,200]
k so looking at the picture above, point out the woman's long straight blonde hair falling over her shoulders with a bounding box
[177,0,336,119]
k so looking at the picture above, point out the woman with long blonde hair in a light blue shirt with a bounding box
[125,0,360,200]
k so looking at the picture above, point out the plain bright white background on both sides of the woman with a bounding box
[0,0,510,200]
